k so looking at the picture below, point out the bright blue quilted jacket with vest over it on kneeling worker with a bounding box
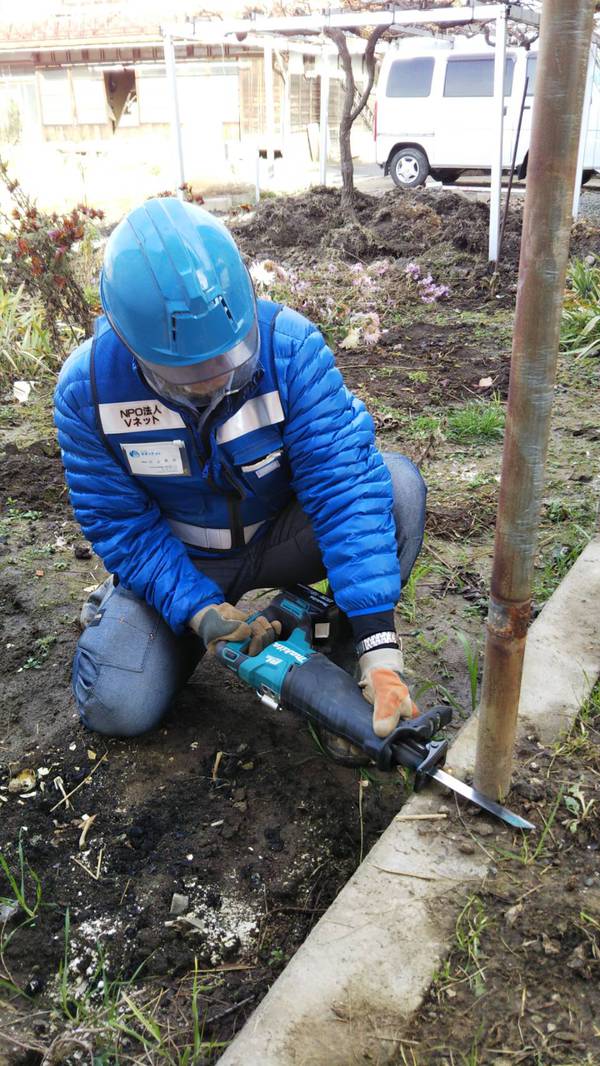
[54,300,400,633]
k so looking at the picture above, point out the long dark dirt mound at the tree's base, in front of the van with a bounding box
[232,187,528,263]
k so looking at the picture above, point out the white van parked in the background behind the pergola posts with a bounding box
[373,36,600,189]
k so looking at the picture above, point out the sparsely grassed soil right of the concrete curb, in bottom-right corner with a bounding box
[392,729,600,1066]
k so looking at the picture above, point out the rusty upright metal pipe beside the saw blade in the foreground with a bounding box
[475,0,594,798]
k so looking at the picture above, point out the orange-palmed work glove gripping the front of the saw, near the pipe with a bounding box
[358,648,419,737]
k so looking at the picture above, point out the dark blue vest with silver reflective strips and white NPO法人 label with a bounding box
[90,301,292,556]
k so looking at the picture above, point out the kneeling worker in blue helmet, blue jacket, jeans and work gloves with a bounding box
[55,198,425,736]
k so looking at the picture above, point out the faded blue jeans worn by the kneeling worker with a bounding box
[72,452,426,737]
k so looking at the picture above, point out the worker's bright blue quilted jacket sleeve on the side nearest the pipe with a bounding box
[276,316,400,616]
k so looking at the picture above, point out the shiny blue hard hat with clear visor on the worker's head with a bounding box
[100,197,259,385]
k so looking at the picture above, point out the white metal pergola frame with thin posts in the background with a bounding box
[162,0,593,263]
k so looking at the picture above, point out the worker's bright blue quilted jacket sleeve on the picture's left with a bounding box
[54,350,224,633]
